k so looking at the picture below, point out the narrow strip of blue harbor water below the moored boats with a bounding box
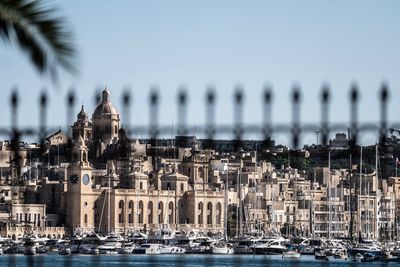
[0,254,398,267]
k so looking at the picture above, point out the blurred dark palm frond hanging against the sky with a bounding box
[0,0,77,81]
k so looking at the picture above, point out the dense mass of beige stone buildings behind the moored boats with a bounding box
[0,89,400,243]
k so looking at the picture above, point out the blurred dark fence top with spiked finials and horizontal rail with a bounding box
[0,84,400,172]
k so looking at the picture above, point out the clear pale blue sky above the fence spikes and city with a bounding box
[0,0,400,147]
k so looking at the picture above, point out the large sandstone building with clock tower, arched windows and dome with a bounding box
[65,90,225,233]
